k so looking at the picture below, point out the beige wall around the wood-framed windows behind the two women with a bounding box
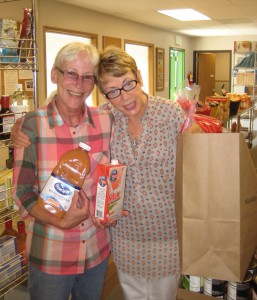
[0,0,192,103]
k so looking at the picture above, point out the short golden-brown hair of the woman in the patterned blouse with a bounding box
[95,46,138,89]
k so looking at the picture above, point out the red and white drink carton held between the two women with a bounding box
[95,159,127,222]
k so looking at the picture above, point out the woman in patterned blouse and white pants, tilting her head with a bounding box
[96,47,184,300]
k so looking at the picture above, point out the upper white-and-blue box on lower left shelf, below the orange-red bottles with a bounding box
[0,235,18,264]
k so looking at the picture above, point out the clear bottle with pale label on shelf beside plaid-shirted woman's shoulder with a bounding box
[10,83,29,121]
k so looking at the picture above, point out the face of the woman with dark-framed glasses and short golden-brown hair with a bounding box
[101,71,147,118]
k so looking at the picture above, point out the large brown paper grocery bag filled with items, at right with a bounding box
[176,133,257,281]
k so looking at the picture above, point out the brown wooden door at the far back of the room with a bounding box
[197,53,216,101]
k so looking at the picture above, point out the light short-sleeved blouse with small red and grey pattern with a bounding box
[111,96,184,279]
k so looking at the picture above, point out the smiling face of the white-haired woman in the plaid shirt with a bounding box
[51,50,94,112]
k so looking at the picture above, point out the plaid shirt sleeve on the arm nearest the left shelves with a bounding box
[12,117,38,218]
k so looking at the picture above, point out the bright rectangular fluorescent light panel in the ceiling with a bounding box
[158,8,210,21]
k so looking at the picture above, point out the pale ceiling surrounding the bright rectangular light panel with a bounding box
[56,0,257,36]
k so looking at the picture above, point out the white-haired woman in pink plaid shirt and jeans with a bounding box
[12,42,112,300]
